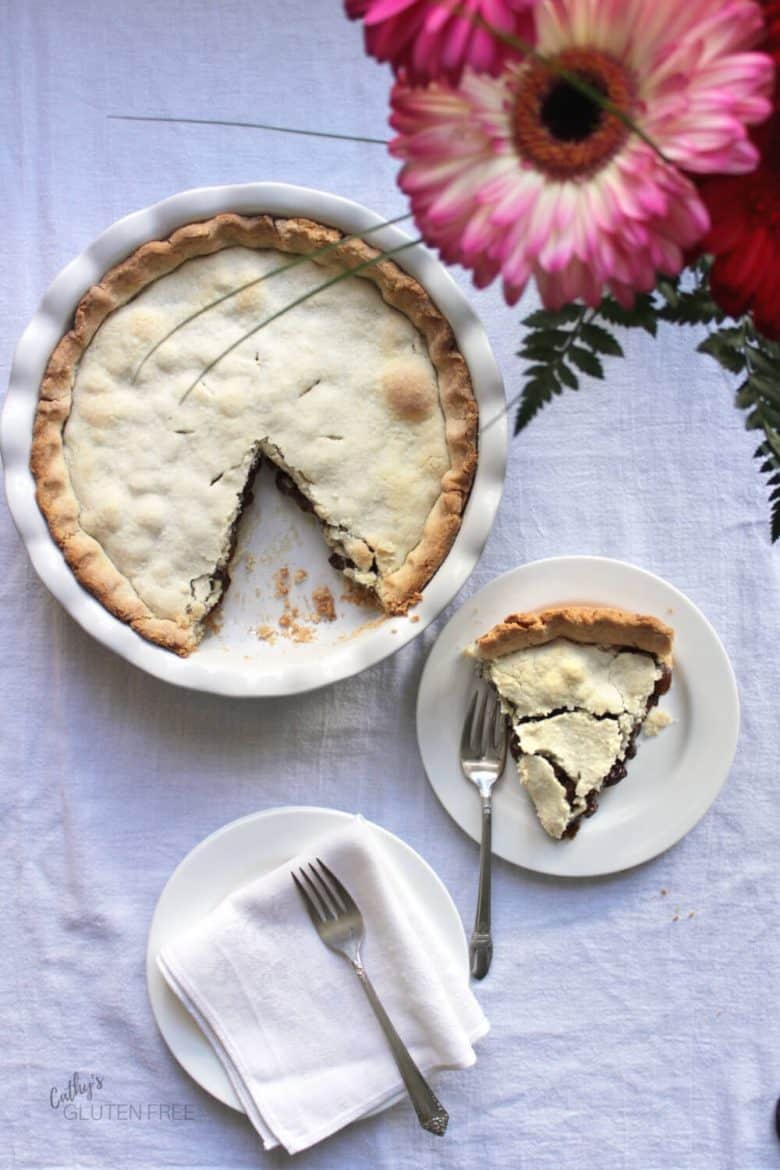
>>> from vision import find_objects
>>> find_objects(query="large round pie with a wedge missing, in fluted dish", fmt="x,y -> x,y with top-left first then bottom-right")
32,214 -> 477,654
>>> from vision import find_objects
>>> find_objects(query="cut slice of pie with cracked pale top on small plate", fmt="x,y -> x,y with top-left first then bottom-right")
472,605 -> 674,839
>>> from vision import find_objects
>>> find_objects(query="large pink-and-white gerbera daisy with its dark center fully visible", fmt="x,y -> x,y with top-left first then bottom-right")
391,0 -> 773,308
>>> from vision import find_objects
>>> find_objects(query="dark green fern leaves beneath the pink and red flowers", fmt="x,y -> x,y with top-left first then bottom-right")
515,259 -> 780,541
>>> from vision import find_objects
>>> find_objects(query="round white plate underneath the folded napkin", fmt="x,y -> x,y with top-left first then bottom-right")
146,806 -> 469,1112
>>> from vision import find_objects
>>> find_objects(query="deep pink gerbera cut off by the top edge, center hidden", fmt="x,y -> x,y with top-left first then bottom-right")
345,0 -> 536,83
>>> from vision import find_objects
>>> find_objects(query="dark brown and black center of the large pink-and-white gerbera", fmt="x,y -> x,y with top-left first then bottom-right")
512,49 -> 636,180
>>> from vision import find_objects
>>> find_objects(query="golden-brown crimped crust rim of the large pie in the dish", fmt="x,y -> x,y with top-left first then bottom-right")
30,213 -> 477,655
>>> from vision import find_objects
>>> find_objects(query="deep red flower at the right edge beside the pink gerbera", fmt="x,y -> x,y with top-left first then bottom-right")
699,0 -> 780,340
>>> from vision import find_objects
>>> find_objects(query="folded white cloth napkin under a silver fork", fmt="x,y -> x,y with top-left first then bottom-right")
158,817 -> 489,1154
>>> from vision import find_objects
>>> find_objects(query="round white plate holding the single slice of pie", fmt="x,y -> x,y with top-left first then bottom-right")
417,557 -> 739,878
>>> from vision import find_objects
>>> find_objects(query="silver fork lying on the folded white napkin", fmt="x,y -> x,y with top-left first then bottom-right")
291,858 -> 449,1136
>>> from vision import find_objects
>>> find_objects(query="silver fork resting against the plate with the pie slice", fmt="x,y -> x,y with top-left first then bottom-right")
461,688 -> 509,979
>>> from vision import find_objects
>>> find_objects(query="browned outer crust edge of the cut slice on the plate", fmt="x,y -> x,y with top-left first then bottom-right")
474,605 -> 674,667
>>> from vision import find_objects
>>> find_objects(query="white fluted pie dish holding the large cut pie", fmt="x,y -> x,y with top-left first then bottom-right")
0,183 -> 506,696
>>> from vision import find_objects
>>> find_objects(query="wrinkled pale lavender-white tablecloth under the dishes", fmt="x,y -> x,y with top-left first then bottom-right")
0,0 -> 780,1170
